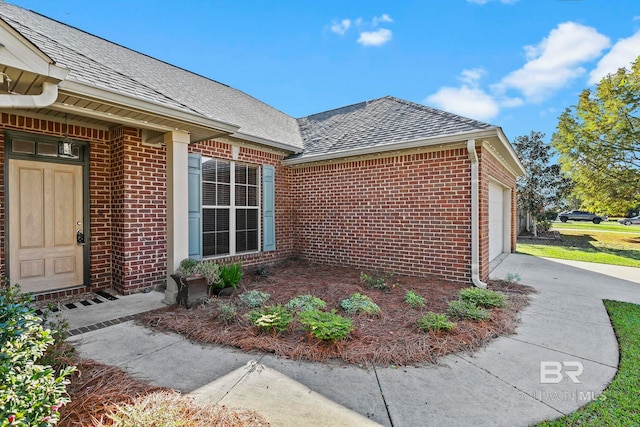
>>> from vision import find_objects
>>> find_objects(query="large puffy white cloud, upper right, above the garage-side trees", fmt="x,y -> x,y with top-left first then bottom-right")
492,22 -> 609,102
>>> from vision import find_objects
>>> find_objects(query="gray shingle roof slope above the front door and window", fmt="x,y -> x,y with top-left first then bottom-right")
0,2 -> 302,147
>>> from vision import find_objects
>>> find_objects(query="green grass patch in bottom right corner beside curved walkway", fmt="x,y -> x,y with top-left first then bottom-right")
538,301 -> 640,427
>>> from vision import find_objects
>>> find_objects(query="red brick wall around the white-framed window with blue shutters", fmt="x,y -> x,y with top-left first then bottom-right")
189,141 -> 293,266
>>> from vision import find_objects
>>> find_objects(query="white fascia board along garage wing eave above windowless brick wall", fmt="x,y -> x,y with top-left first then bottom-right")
282,128 -> 497,166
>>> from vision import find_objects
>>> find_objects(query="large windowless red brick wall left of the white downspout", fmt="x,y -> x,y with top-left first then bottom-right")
293,148 -> 471,281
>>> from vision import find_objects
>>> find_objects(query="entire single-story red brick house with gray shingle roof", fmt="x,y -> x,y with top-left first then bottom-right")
0,3 -> 523,302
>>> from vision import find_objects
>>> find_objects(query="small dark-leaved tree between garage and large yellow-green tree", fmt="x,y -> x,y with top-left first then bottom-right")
513,131 -> 571,234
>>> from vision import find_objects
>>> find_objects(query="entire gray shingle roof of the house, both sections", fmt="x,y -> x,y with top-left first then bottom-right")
0,0 -> 496,158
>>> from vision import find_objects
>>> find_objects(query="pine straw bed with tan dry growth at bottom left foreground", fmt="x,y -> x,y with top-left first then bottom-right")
57,360 -> 269,427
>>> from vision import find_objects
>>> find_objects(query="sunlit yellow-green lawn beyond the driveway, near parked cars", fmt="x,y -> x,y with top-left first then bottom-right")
517,222 -> 640,267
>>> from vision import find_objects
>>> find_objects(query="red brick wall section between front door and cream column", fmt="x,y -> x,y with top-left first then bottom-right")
110,127 -> 167,294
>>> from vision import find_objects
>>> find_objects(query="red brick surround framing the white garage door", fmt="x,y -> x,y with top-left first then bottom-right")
476,148 -> 517,280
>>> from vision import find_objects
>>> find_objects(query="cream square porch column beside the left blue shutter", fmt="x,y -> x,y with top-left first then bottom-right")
163,132 -> 189,304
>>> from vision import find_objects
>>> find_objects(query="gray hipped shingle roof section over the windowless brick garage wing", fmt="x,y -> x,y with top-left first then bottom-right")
291,96 -> 496,158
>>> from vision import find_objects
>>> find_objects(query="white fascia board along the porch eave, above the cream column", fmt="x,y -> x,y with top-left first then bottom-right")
60,80 -> 240,133
